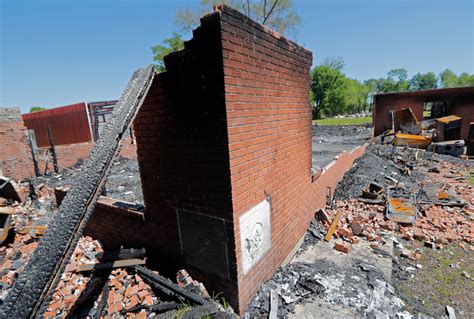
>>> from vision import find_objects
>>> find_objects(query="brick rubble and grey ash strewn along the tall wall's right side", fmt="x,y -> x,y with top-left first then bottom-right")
245,144 -> 474,318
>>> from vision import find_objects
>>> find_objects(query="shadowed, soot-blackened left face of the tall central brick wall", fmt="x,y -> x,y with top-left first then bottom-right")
135,10 -> 237,300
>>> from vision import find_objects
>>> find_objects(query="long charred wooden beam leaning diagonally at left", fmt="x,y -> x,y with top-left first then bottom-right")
0,65 -> 154,318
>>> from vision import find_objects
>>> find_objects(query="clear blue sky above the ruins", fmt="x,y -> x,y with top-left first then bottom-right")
0,0 -> 474,112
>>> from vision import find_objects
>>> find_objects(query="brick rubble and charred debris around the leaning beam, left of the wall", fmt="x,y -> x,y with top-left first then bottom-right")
0,174 -> 230,318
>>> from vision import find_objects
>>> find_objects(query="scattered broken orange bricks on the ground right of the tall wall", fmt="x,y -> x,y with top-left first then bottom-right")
320,149 -> 474,257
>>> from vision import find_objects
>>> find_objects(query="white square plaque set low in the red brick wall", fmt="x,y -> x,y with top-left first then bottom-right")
239,199 -> 272,274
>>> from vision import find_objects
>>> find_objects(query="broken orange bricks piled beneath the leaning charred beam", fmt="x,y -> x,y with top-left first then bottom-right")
0,234 -> 209,319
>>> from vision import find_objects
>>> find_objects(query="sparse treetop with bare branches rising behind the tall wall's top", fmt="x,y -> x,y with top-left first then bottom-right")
151,0 -> 300,71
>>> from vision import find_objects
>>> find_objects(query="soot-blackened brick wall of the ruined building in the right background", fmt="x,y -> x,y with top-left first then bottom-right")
374,86 -> 474,140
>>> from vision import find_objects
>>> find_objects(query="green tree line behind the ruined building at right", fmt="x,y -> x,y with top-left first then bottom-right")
310,58 -> 474,119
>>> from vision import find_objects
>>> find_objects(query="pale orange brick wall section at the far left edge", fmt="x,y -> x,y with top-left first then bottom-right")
0,108 -> 35,180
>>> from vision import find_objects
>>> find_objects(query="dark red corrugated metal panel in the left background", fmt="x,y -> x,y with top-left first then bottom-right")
22,102 -> 91,147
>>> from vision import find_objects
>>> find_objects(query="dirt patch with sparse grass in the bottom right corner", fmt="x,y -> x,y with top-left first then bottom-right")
393,243 -> 474,318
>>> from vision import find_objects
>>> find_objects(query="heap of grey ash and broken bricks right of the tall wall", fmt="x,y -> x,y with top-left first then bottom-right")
328,145 -> 474,252
